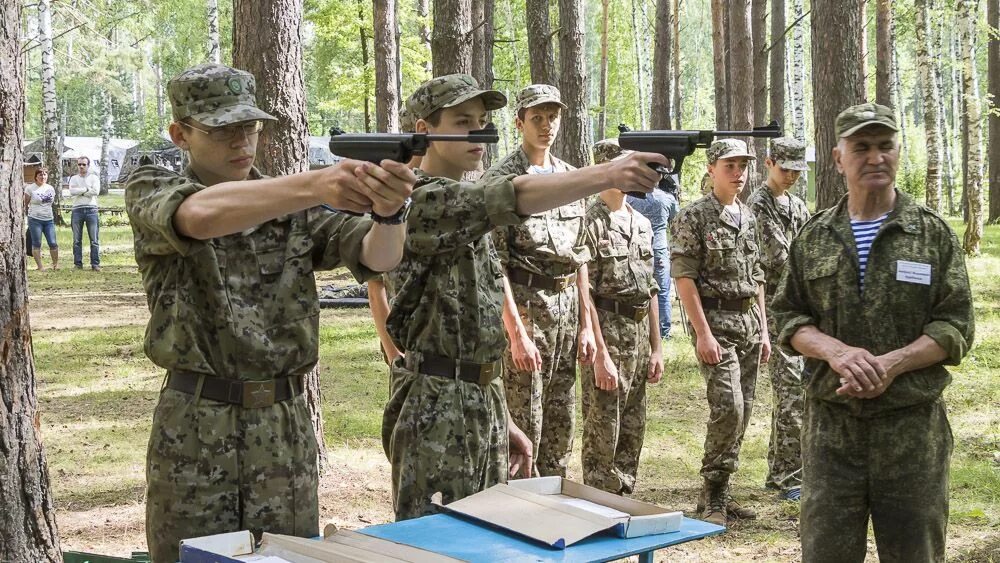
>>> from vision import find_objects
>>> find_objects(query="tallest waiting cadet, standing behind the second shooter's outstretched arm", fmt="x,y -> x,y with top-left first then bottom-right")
483,84 -> 594,477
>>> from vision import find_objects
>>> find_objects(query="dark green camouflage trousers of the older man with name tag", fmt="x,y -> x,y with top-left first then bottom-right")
799,399 -> 952,563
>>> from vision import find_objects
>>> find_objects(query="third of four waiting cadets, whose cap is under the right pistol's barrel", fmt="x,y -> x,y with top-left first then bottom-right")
670,139 -> 771,525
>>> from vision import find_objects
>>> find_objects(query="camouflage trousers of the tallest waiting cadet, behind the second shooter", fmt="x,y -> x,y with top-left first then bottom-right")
504,283 -> 579,477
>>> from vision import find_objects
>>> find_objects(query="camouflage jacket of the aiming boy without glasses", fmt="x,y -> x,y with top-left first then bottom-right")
386,170 -> 521,363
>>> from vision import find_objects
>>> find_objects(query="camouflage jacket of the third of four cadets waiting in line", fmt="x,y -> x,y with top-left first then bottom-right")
670,192 -> 764,299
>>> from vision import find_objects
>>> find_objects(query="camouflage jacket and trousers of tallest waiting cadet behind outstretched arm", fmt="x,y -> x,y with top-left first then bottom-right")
483,148 -> 590,476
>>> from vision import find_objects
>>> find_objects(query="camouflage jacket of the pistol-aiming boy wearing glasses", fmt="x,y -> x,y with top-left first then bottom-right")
125,166 -> 375,380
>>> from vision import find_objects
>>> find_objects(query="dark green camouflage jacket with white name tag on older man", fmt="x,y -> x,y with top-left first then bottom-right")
772,191 -> 975,416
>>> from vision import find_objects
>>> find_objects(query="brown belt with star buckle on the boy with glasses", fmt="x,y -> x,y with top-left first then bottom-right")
167,370 -> 303,409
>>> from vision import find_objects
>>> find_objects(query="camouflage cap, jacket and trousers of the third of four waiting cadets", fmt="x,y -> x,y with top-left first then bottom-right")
670,139 -> 764,490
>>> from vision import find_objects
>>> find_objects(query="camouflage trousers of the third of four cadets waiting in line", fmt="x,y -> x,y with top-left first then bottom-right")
695,307 -> 761,483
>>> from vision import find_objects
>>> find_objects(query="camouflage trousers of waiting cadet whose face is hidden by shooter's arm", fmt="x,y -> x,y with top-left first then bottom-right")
580,310 -> 650,494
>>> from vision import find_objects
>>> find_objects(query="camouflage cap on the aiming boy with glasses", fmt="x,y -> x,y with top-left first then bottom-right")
167,64 -> 278,127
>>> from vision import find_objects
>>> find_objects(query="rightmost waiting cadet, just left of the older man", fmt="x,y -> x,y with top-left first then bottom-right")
747,137 -> 809,500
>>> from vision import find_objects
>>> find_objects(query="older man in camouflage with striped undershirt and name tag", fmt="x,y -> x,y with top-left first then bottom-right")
772,104 -> 975,563
